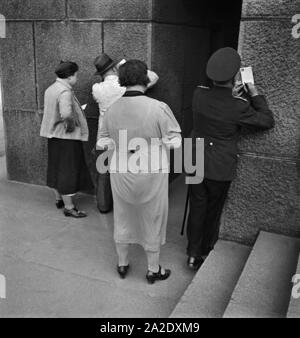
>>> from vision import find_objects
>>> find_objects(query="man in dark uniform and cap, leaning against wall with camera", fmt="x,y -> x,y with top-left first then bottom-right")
187,47 -> 274,270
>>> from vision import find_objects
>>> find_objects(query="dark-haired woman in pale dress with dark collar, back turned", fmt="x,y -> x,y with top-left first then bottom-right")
97,60 -> 181,283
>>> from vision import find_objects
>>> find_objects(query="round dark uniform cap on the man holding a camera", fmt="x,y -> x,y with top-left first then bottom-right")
206,47 -> 241,82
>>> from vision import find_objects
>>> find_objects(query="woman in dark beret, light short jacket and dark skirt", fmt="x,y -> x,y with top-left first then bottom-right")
40,61 -> 89,218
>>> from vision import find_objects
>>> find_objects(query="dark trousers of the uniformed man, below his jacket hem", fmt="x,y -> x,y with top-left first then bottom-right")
187,178 -> 231,259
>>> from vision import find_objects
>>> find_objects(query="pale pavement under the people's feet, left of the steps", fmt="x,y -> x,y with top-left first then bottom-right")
0,156 -> 194,318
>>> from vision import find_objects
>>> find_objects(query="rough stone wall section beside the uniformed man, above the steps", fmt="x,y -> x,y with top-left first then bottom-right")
221,0 -> 300,243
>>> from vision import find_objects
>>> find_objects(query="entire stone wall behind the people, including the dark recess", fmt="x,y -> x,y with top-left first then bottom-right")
0,0 -> 300,244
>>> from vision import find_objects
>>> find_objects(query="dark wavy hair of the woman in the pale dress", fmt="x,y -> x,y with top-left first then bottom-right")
119,60 -> 150,87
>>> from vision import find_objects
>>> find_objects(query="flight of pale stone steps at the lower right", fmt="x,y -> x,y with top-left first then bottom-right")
170,231 -> 300,318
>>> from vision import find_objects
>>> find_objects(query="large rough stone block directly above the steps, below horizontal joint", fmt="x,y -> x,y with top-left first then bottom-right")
221,156 -> 300,244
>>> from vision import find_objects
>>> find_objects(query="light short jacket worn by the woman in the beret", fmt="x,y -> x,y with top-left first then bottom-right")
40,78 -> 89,141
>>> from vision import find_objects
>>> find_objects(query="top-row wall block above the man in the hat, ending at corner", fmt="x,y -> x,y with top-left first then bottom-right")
68,0 -> 152,20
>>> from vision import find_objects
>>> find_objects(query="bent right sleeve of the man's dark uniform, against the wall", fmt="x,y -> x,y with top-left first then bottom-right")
239,95 -> 275,129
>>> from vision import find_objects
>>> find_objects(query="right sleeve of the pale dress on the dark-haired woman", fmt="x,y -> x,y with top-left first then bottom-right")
159,104 -> 181,148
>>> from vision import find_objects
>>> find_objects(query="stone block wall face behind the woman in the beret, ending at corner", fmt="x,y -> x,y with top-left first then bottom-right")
0,0 -> 152,184
